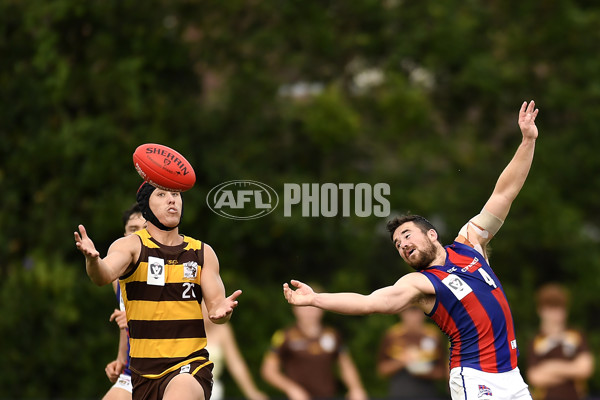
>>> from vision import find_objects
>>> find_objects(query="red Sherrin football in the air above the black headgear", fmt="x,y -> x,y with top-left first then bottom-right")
133,143 -> 196,192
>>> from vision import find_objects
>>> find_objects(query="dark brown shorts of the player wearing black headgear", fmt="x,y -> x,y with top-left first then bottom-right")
131,360 -> 214,400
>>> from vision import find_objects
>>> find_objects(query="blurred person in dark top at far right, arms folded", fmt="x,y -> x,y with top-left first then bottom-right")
527,283 -> 594,400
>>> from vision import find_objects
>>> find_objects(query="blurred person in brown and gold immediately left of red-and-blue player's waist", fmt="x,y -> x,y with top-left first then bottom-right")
377,307 -> 448,399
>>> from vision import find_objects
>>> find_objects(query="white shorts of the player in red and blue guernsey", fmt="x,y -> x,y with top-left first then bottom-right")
450,367 -> 531,400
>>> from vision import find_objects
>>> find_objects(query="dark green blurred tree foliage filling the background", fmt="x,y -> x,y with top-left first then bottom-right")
0,0 -> 600,398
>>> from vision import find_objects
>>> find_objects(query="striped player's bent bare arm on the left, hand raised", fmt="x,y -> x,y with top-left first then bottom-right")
74,225 -> 141,286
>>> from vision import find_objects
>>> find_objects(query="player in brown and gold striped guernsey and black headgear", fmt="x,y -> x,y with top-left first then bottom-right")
74,182 -> 242,400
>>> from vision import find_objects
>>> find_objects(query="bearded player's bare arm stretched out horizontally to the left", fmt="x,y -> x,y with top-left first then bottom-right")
283,273 -> 435,315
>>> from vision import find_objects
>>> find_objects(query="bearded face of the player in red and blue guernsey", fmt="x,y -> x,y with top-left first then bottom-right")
393,221 -> 437,271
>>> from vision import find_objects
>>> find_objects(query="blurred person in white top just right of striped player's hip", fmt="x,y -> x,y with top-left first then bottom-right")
202,302 -> 268,400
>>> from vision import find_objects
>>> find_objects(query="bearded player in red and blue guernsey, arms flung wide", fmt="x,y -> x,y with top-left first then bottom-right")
283,101 -> 538,400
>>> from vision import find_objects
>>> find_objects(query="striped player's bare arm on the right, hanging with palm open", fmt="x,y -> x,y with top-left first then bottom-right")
201,243 -> 242,324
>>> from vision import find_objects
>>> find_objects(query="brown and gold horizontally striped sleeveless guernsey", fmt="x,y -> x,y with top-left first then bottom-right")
119,229 -> 211,379
